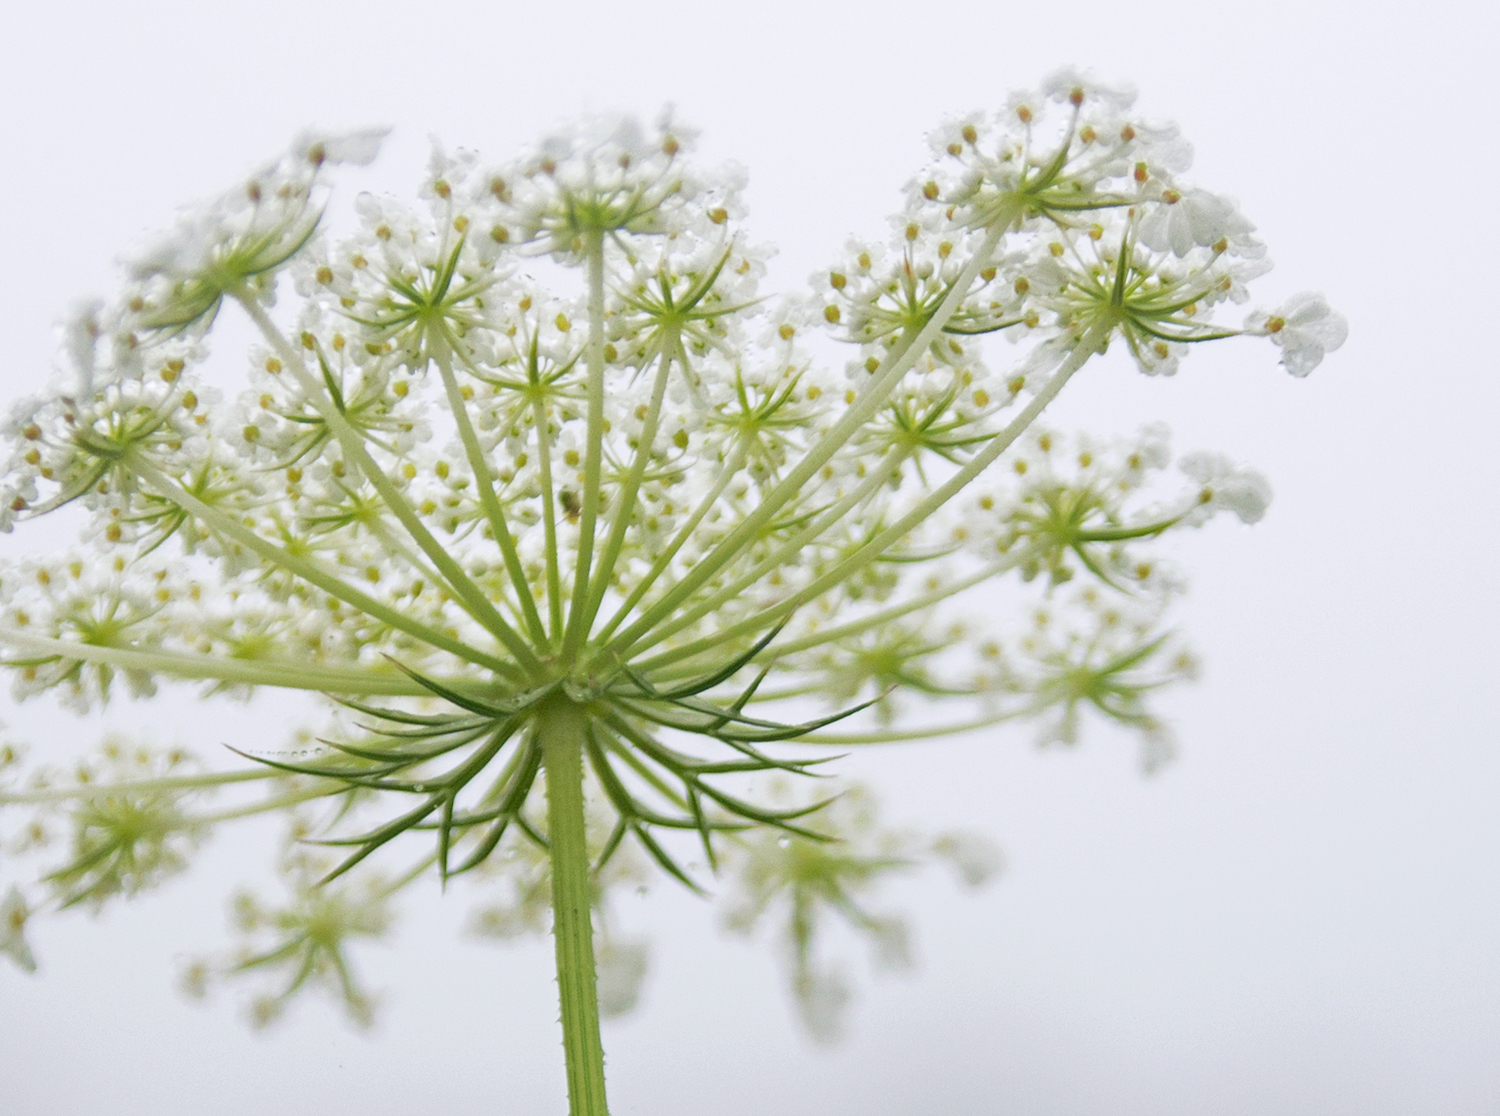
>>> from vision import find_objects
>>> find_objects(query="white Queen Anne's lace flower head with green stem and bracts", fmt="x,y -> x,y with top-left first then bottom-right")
0,78 -> 1346,1113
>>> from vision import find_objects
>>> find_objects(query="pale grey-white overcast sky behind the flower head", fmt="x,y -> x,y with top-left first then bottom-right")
0,0 -> 1500,1116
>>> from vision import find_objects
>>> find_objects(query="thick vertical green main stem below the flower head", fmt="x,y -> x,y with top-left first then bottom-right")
537,698 -> 609,1116
